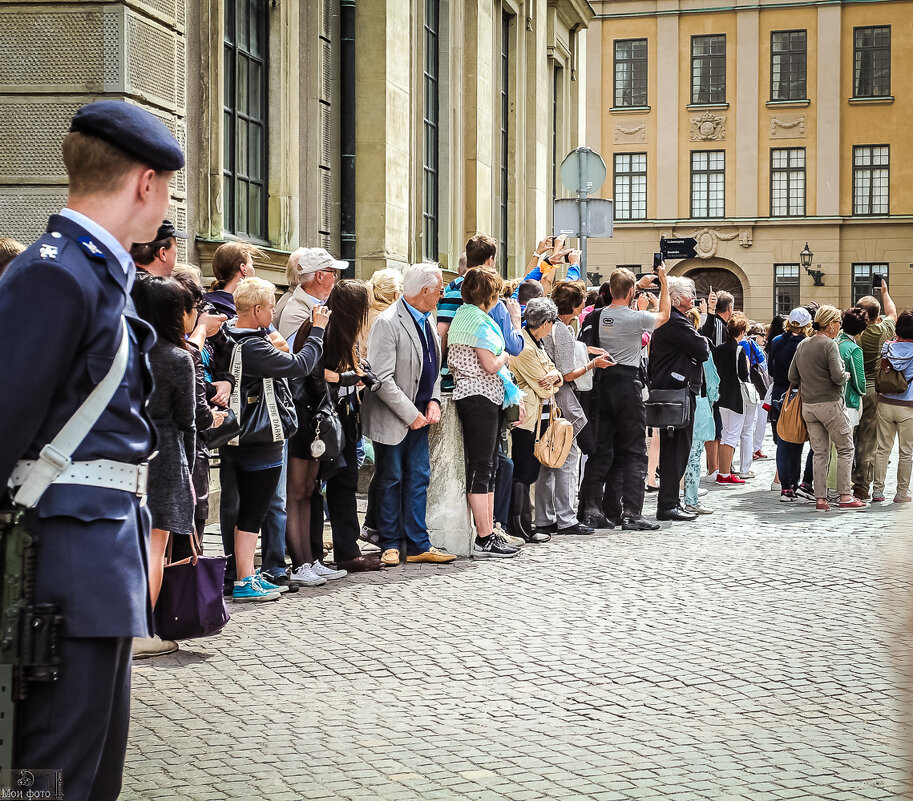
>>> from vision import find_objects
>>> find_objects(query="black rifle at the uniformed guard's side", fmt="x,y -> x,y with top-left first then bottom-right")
0,504 -> 63,771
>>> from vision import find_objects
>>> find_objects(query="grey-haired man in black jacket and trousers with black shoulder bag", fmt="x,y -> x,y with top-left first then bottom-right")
649,277 -> 710,521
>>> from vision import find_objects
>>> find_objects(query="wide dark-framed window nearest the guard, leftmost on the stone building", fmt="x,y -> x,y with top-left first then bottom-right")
222,0 -> 269,242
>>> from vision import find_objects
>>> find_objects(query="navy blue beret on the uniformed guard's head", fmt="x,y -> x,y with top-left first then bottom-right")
70,100 -> 184,171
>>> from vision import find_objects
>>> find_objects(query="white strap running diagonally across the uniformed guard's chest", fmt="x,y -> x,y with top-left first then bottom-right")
13,317 -> 130,509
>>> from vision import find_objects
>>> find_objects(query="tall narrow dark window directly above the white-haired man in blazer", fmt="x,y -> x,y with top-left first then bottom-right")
422,0 -> 441,261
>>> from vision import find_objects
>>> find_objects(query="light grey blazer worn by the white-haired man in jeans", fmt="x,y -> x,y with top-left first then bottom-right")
361,298 -> 441,445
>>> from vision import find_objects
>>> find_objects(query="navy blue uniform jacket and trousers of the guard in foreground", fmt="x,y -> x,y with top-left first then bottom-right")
0,216 -> 155,801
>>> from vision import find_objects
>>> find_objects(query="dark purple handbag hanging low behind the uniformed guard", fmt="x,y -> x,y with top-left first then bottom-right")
152,534 -> 230,640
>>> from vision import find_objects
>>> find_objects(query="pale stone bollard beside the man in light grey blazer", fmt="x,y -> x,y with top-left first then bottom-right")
426,395 -> 475,556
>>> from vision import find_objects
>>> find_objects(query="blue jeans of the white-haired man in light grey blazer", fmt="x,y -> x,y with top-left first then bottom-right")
374,427 -> 431,556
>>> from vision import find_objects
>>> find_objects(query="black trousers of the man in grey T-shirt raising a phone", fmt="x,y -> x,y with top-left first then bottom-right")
580,365 -> 647,518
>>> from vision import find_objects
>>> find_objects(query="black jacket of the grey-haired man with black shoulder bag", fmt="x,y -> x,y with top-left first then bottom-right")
648,308 -> 710,395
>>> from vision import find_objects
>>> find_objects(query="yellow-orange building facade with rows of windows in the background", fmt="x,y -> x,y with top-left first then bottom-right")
587,0 -> 913,321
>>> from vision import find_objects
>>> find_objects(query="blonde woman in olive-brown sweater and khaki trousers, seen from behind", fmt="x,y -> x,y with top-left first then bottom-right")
789,306 -> 868,512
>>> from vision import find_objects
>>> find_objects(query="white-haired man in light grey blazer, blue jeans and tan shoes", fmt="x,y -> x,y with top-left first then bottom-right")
361,264 -> 456,567
